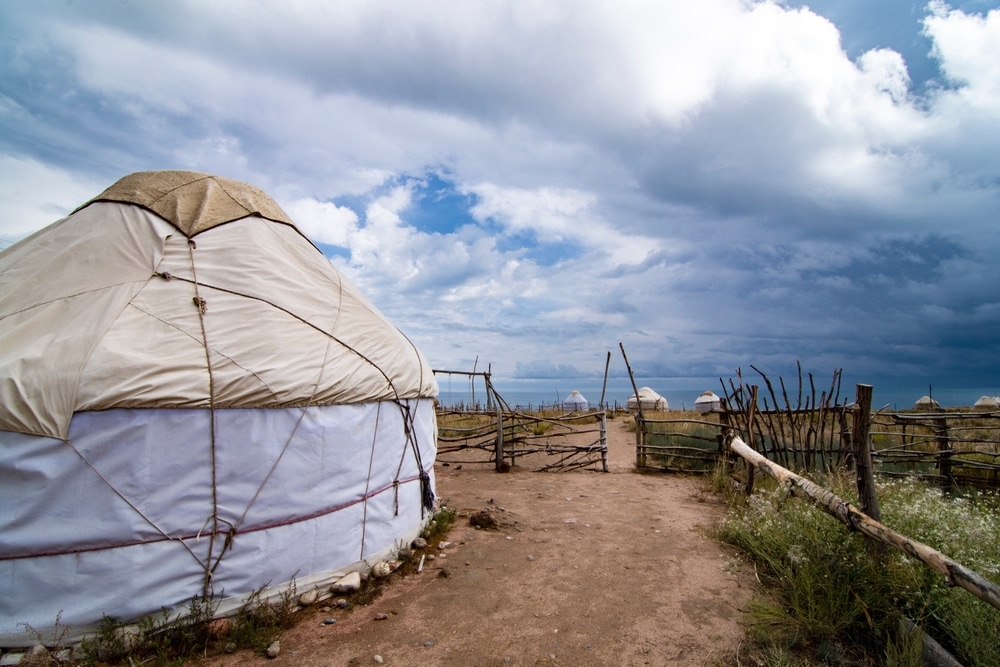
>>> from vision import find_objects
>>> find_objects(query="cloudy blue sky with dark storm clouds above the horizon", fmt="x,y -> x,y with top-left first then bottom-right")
0,0 -> 1000,389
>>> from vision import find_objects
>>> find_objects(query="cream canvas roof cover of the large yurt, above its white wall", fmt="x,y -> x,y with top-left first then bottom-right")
0,172 -> 437,438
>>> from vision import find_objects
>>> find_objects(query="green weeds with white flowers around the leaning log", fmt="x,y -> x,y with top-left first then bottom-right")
716,476 -> 1000,667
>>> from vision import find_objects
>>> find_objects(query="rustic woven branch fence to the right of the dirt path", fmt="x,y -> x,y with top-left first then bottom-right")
633,388 -> 1000,491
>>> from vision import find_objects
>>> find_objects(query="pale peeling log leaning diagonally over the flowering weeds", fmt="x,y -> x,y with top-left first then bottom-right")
727,434 -> 1000,609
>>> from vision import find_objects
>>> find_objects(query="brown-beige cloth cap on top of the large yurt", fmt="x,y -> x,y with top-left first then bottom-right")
84,171 -> 293,237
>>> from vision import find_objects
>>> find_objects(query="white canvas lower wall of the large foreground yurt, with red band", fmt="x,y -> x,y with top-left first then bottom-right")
0,399 -> 436,646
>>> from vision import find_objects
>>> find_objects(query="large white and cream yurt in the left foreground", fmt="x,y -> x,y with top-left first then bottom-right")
0,171 -> 437,646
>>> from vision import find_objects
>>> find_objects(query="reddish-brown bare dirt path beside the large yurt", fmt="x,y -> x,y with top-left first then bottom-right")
198,419 -> 753,667
